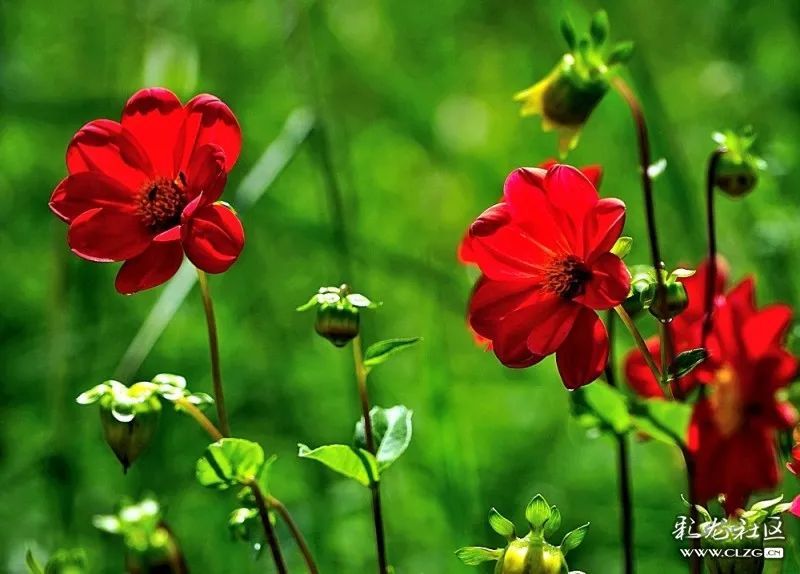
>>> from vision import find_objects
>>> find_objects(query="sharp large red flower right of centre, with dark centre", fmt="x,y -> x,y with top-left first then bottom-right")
469,165 -> 630,389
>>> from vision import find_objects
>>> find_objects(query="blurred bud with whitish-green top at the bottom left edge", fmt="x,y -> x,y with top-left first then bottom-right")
93,497 -> 189,574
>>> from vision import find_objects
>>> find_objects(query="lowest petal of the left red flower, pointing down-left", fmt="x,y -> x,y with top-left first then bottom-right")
115,241 -> 183,295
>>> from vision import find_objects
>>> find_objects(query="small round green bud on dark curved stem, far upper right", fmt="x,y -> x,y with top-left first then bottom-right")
713,128 -> 766,197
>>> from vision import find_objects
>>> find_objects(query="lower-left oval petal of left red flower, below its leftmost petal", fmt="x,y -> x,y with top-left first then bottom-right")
68,208 -> 151,261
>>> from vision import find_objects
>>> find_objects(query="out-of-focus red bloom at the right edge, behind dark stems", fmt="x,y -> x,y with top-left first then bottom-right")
626,258 -> 798,513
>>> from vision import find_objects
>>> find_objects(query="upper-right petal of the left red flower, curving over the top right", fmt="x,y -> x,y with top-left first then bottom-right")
175,94 -> 242,171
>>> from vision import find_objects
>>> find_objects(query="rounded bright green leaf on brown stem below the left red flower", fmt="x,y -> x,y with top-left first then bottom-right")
196,438 -> 264,490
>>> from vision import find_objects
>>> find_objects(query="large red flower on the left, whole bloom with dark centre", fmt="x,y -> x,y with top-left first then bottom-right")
50,88 -> 244,294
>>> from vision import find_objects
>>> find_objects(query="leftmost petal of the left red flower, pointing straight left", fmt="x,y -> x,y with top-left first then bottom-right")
50,171 -> 138,223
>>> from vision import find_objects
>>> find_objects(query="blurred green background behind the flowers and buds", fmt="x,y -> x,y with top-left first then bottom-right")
0,0 -> 800,574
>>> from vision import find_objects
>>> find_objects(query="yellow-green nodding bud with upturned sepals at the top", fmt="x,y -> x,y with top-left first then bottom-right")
514,11 -> 633,156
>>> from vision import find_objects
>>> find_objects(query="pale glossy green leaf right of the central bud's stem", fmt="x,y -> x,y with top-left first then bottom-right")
355,405 -> 414,472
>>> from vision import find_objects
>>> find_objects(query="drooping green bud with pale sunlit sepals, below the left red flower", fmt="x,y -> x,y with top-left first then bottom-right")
77,381 -> 161,472
